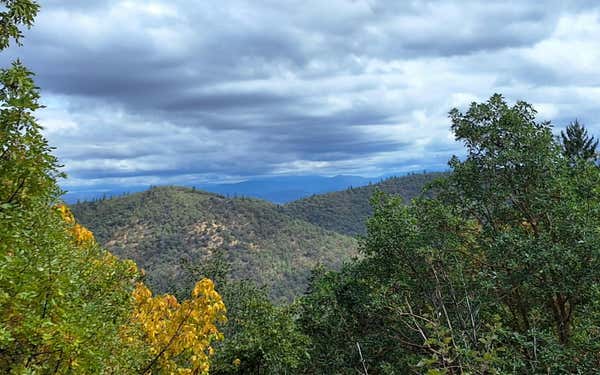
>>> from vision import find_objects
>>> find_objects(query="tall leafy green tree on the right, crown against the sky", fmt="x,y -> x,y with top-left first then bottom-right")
448,95 -> 600,352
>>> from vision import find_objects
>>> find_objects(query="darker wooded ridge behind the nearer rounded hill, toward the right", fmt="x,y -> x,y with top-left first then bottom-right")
283,172 -> 444,236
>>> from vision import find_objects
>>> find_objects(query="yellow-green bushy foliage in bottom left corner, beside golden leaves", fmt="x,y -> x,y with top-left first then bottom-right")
0,201 -> 137,373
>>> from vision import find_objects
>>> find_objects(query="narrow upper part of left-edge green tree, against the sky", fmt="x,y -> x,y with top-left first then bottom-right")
0,0 -> 60,210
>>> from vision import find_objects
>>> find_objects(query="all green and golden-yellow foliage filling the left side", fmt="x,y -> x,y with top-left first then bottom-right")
0,0 -> 224,374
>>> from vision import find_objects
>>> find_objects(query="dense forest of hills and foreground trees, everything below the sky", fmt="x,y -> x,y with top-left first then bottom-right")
0,0 -> 600,375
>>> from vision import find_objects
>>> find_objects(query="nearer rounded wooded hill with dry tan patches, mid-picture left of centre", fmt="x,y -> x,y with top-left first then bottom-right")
72,187 -> 356,299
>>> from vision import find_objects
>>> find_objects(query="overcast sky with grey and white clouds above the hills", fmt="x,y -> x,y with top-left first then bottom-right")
3,0 -> 600,194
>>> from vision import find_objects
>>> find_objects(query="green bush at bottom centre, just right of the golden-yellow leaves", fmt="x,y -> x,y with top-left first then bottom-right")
183,249 -> 308,374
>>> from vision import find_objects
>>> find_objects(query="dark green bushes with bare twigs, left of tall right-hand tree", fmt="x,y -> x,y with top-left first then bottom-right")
303,198 -> 506,374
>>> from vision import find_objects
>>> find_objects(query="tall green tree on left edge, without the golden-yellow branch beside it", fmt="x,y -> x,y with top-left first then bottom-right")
0,0 -> 137,373
